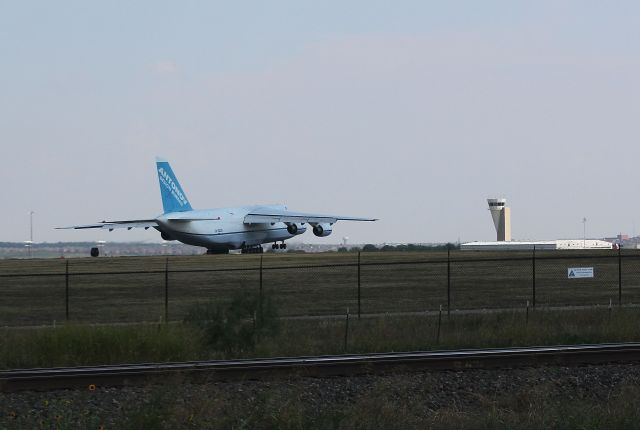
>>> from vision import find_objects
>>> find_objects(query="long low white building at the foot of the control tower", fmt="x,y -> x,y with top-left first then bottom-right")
460,239 -> 613,251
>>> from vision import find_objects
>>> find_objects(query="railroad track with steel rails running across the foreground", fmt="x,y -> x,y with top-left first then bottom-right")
0,343 -> 640,391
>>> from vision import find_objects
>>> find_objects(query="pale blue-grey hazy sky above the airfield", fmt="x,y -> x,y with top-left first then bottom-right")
0,0 -> 640,243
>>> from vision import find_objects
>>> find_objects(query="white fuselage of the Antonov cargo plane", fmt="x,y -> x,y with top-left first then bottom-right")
156,205 -> 306,250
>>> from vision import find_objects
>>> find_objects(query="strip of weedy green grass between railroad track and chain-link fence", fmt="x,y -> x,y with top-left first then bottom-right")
0,308 -> 640,369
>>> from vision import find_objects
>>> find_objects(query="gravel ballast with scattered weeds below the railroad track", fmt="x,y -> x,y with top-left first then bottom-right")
0,364 -> 640,429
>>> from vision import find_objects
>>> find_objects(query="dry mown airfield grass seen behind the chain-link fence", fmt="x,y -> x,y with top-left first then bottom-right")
0,250 -> 640,326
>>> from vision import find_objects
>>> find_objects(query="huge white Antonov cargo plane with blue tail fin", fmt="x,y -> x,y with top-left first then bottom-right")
57,157 -> 377,254
